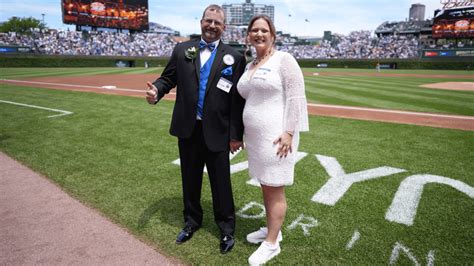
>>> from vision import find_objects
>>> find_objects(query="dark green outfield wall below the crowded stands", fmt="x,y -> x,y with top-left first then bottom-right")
0,54 -> 474,70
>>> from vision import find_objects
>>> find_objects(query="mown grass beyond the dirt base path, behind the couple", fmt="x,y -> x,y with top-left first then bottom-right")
0,68 -> 474,115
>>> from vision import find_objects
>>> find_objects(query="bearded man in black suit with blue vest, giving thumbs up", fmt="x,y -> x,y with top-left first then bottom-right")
146,5 -> 246,254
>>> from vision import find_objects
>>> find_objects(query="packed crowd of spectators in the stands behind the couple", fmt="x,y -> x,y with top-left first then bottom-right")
0,27 -> 419,59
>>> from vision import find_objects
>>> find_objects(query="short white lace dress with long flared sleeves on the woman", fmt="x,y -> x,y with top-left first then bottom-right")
237,51 -> 309,187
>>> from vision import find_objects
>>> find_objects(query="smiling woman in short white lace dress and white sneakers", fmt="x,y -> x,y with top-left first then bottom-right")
237,15 -> 309,264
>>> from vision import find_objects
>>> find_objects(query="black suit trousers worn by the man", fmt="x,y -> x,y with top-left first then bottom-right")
178,120 -> 235,235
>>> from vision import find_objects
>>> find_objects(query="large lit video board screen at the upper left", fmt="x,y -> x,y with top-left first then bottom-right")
62,0 -> 148,31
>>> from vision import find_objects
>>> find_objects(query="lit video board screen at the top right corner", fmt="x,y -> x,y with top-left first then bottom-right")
432,8 -> 474,38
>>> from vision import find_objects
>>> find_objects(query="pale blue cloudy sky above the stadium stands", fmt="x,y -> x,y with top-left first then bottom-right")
0,0 -> 441,36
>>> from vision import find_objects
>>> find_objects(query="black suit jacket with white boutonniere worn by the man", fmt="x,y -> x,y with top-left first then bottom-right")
153,39 -> 246,152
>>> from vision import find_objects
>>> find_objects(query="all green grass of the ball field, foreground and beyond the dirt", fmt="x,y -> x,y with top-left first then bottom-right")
0,68 -> 474,265
